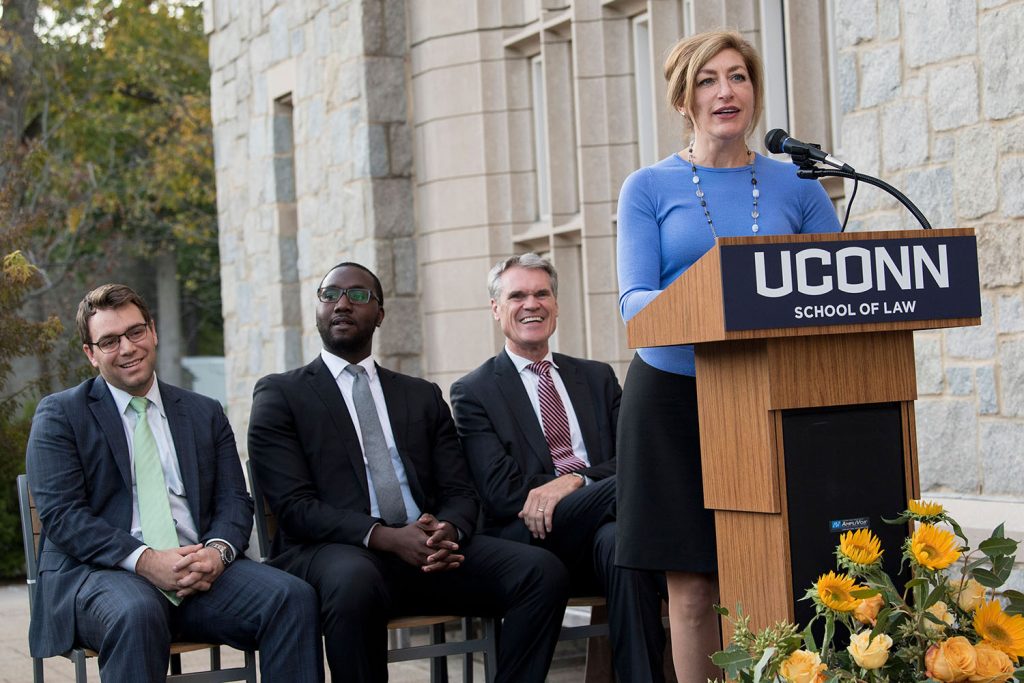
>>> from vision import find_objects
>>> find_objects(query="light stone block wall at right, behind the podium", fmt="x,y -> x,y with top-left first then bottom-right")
836,0 -> 1024,509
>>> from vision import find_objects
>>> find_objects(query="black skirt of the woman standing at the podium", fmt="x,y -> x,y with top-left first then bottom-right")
615,355 -> 718,573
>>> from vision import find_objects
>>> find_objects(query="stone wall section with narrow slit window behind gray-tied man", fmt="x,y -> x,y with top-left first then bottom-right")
205,0 -> 422,444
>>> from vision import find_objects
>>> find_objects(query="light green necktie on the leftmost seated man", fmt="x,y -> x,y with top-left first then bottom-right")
128,396 -> 181,605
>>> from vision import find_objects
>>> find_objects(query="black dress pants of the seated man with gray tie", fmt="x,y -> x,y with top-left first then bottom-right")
303,536 -> 568,683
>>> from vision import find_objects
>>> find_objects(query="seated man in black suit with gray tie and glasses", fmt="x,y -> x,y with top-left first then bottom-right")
249,263 -> 568,683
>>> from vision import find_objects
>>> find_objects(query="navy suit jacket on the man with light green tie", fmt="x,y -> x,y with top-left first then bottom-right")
26,377 -> 253,657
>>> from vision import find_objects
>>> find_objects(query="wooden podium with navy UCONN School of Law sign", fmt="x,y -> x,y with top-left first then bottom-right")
628,229 -> 981,634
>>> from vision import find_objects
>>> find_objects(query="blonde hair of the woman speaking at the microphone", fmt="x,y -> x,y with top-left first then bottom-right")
665,31 -> 765,134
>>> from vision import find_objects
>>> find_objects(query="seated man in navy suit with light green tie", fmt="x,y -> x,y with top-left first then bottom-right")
27,285 -> 324,683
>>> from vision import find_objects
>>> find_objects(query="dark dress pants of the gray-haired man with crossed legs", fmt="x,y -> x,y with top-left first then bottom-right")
531,477 -> 667,683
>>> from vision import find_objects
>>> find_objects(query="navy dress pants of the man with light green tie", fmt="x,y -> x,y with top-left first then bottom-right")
75,557 -> 324,683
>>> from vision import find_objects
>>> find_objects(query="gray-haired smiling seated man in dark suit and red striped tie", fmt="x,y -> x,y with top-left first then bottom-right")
452,254 -> 665,683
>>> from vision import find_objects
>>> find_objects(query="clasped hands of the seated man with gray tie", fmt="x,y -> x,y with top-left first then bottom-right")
369,513 -> 466,571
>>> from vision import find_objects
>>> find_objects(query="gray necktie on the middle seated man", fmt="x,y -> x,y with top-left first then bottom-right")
345,365 -> 409,524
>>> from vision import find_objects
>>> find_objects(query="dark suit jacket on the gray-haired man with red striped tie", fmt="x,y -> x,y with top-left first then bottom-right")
452,350 -> 622,541
